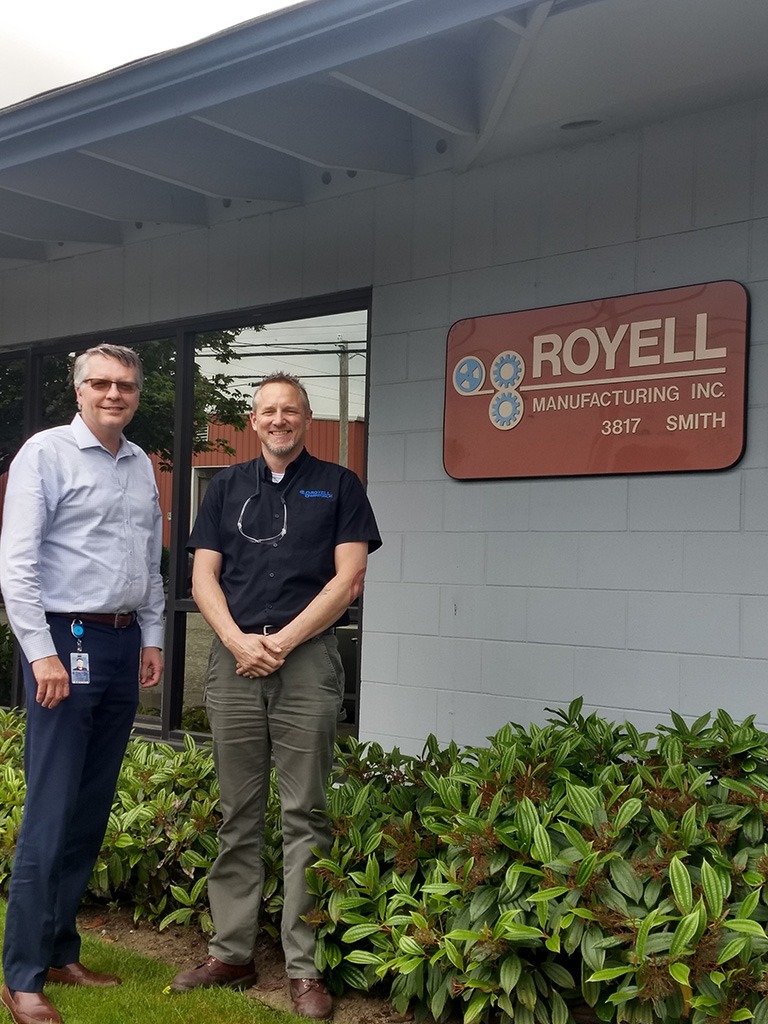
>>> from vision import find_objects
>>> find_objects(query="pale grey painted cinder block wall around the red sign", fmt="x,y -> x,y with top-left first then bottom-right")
0,98 -> 768,752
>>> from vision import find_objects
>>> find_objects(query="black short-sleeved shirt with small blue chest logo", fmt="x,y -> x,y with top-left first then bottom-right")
187,450 -> 381,633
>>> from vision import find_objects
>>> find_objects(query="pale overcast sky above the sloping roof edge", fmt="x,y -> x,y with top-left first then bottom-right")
0,0 -> 307,109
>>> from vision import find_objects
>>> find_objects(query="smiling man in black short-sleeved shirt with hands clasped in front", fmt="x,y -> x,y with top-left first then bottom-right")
171,374 -> 381,1019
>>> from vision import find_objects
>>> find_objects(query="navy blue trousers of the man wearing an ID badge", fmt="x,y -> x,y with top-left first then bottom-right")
3,615 -> 141,992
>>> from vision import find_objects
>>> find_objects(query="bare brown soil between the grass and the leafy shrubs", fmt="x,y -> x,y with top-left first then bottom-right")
78,906 -> 403,1024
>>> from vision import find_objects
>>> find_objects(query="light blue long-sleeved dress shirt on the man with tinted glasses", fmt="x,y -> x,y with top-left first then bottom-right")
0,415 -> 165,662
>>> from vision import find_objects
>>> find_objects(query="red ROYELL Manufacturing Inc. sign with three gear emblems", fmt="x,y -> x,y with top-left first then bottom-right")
443,281 -> 748,480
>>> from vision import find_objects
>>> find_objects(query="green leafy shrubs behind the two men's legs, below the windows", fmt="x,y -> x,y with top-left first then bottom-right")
0,711 -> 282,936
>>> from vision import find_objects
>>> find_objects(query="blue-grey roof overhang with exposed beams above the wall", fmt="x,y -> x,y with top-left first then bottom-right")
0,0 -> 768,269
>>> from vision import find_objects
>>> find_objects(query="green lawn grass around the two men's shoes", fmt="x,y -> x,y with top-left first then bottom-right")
0,901 -> 297,1024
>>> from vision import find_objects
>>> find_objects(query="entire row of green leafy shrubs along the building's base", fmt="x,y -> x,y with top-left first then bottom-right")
0,700 -> 768,1024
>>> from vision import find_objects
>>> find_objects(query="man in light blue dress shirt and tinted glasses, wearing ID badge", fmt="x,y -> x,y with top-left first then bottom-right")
0,344 -> 165,1024
